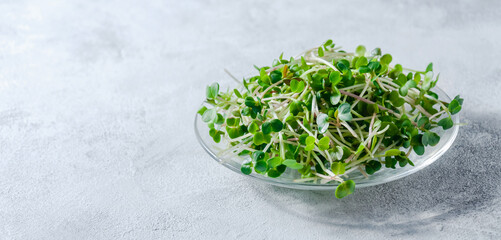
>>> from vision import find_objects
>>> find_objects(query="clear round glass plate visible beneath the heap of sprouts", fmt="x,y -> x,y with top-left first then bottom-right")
195,87 -> 459,190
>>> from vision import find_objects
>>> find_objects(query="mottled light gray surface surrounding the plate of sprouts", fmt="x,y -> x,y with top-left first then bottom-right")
0,0 -> 501,239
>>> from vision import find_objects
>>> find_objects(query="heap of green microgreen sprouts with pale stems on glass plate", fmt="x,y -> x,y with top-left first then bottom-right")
198,40 -> 463,198
